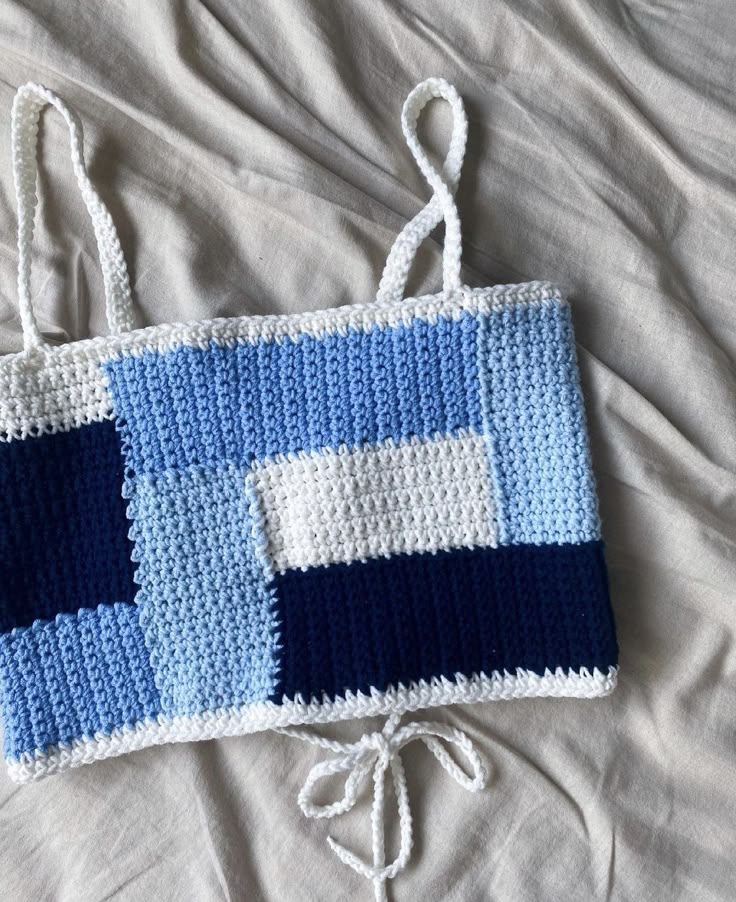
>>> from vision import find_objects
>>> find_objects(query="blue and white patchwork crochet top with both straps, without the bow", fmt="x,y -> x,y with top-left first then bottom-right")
0,80 -> 617,781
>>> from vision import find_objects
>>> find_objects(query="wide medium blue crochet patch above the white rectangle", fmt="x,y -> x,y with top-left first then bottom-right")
105,313 -> 481,474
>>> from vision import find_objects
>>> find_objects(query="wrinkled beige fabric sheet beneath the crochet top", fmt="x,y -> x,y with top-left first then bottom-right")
0,0 -> 736,902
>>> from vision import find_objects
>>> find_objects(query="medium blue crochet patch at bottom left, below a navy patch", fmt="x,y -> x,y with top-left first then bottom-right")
0,604 -> 161,758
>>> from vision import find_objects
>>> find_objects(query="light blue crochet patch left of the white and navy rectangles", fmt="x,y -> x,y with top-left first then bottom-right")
127,464 -> 278,715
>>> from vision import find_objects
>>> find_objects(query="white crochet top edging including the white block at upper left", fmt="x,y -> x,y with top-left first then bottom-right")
0,282 -> 563,441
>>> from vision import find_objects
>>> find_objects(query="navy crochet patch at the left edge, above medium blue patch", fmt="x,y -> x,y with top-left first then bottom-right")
0,421 -> 136,632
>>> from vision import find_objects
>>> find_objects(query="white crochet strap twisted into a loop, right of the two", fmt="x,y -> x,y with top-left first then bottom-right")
376,78 -> 468,303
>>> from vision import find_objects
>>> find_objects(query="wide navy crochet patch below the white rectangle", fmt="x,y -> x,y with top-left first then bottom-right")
274,542 -> 618,701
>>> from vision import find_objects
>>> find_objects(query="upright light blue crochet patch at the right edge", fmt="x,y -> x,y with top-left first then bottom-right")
478,300 -> 600,545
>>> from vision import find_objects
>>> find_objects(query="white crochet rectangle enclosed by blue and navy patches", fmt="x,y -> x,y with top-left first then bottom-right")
248,431 -> 497,572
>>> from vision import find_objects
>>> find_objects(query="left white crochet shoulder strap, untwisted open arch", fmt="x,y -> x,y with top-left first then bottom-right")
11,82 -> 133,351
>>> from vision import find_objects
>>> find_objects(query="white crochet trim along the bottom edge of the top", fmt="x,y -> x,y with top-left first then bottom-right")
6,667 -> 618,783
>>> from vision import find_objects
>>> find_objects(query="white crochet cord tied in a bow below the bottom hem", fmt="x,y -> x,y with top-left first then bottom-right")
277,714 -> 488,902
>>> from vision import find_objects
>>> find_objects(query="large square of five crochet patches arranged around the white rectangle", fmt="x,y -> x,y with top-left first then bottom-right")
100,296 -> 615,714
